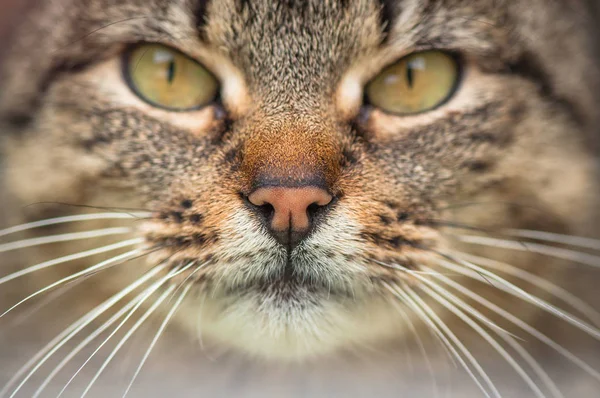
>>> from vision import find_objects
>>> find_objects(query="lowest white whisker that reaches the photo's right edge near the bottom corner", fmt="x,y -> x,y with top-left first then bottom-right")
436,262 -> 600,380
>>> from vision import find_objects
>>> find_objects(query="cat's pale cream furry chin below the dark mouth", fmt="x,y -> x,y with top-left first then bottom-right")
179,294 -> 407,362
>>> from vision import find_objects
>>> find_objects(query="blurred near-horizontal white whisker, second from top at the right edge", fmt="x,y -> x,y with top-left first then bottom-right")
457,235 -> 600,267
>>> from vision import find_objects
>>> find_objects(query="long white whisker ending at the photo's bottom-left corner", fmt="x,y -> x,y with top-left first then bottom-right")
0,264 -> 167,398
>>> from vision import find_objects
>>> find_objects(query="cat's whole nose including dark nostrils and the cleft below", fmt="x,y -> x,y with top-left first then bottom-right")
248,186 -> 333,249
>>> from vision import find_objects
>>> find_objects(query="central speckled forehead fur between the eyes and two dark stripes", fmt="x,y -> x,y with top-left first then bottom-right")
200,0 -> 384,107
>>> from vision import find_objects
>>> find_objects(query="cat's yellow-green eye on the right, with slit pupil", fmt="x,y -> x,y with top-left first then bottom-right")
366,51 -> 459,115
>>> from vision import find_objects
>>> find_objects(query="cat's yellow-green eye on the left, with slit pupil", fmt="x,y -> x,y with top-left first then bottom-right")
125,44 -> 219,111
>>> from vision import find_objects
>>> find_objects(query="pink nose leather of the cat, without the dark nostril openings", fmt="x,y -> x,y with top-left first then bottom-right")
248,187 -> 333,232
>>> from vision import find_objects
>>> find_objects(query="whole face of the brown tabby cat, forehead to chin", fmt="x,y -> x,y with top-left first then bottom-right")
0,0 -> 600,358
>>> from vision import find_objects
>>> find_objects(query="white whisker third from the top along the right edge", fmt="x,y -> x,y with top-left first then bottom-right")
451,251 -> 600,326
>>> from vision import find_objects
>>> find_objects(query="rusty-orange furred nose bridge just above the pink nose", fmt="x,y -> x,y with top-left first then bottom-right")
242,115 -> 340,190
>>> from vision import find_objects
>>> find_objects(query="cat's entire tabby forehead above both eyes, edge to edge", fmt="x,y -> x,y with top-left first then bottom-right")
0,0 -> 591,134
